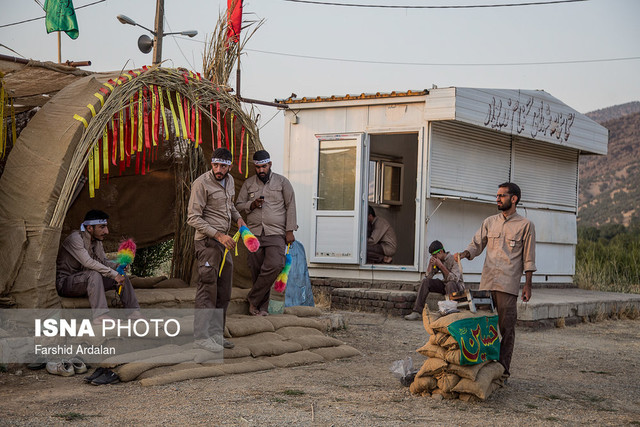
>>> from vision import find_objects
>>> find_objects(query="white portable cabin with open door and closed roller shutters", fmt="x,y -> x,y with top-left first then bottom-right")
278,87 -> 608,283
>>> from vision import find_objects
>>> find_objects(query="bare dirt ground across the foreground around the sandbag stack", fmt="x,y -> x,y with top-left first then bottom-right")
0,312 -> 640,426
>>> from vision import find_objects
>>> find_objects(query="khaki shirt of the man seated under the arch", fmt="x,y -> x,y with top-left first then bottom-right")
56,230 -> 118,282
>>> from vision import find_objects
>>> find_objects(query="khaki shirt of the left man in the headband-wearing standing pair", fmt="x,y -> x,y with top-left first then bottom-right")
187,171 -> 240,240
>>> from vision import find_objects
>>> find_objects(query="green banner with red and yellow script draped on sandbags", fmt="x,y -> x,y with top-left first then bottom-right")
447,316 -> 500,365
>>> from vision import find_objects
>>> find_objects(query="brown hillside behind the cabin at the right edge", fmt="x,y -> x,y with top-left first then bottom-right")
578,107 -> 640,226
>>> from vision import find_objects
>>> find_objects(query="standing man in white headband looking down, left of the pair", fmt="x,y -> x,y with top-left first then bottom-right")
187,148 -> 245,352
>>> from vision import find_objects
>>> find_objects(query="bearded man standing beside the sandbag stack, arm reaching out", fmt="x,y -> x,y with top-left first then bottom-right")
456,182 -> 536,375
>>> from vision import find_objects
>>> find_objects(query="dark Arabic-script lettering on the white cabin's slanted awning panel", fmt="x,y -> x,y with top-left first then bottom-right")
484,96 -> 575,142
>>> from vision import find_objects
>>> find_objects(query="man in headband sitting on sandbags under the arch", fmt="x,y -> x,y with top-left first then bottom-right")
56,209 -> 140,324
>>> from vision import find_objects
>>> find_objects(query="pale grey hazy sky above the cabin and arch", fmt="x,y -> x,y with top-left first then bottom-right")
0,0 -> 640,171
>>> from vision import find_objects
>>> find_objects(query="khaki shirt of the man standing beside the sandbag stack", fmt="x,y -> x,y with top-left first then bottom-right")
467,213 -> 536,295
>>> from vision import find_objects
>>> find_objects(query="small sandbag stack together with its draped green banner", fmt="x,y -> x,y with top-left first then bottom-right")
409,308 -> 504,401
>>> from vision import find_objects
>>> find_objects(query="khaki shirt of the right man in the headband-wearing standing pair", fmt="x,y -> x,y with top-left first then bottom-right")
236,172 -> 298,236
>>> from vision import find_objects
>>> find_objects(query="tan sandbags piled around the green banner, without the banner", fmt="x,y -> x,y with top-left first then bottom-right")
409,308 -> 504,402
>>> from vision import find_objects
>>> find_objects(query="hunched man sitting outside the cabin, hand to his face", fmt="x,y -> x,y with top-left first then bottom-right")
404,240 -> 464,320
